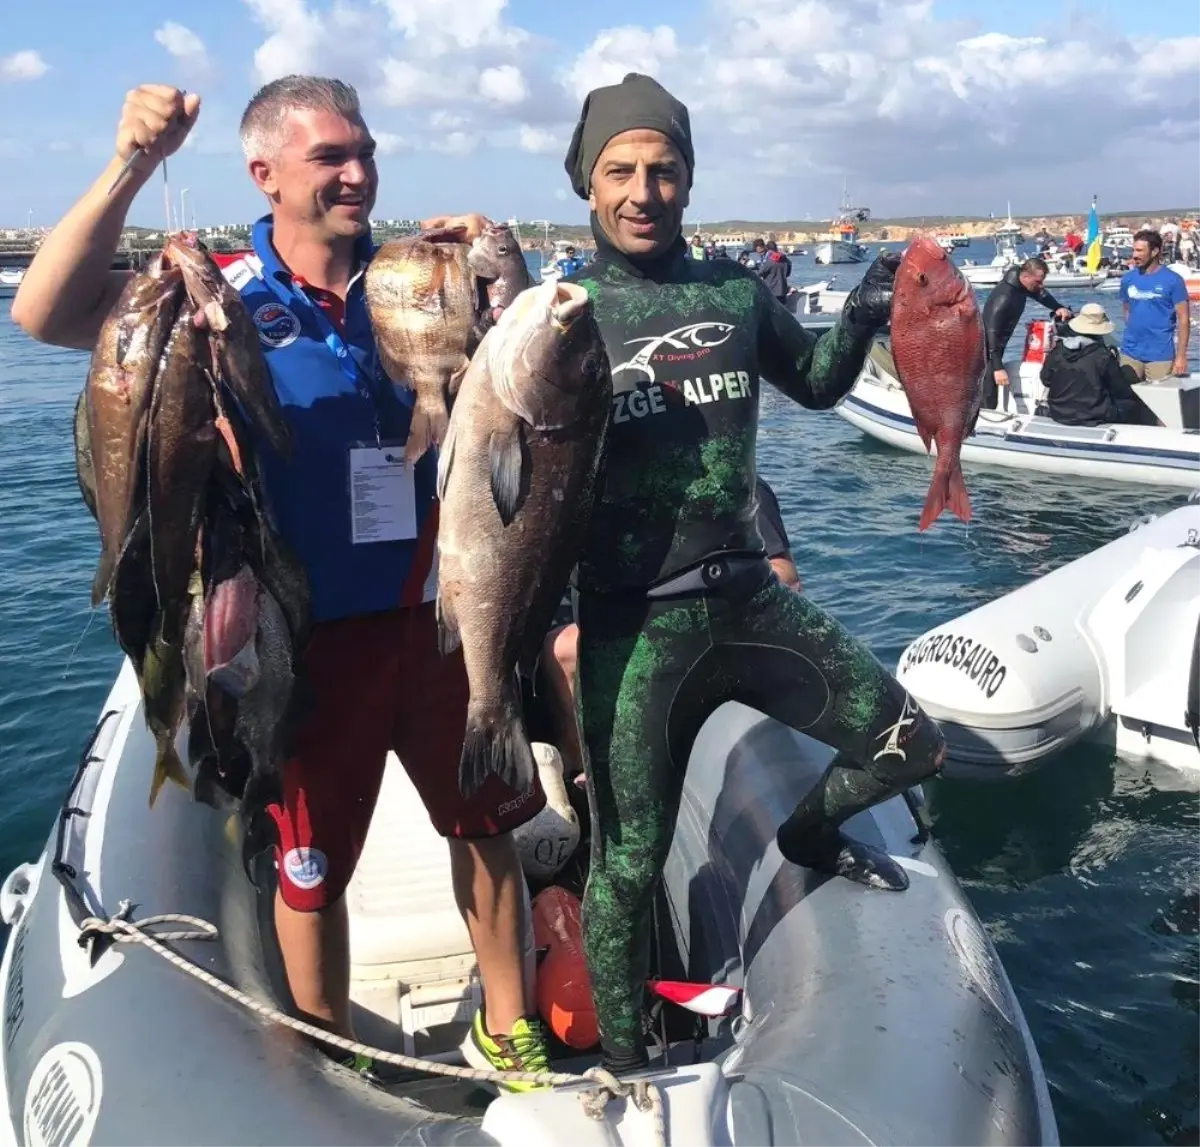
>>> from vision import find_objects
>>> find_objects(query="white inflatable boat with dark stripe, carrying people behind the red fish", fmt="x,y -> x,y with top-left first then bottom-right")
835,319 -> 1200,490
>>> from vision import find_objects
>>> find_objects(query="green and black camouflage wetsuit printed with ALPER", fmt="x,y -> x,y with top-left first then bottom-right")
570,235 -> 942,1070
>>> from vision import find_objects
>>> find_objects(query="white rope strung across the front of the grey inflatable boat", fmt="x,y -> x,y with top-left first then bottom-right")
79,900 -> 667,1147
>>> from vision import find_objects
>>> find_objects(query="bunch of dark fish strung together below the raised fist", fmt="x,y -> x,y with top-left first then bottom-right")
74,235 -> 310,817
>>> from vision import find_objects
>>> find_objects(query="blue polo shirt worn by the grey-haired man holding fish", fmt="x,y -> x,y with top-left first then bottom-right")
223,216 -> 438,621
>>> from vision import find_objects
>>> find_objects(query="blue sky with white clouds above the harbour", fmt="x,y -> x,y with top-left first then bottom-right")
0,0 -> 1200,226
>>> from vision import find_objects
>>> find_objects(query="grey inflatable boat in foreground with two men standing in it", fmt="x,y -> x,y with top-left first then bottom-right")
0,663 -> 1058,1147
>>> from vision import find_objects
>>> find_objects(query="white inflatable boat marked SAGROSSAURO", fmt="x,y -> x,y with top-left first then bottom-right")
896,502 -> 1200,774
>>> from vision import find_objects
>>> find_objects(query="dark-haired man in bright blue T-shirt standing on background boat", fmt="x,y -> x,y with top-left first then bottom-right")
1121,230 -> 1190,383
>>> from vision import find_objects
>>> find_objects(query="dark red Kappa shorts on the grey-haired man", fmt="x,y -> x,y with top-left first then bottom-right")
268,602 -> 546,912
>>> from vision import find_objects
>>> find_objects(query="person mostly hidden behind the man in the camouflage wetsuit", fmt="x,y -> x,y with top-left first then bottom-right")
522,478 -> 804,781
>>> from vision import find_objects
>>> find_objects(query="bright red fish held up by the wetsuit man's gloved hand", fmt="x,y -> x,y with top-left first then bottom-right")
892,235 -> 986,530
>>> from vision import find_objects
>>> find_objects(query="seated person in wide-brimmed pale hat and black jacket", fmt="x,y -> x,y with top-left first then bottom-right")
1042,302 -> 1163,426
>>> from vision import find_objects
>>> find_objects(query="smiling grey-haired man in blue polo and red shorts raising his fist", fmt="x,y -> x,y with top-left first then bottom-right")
12,76 -> 547,1089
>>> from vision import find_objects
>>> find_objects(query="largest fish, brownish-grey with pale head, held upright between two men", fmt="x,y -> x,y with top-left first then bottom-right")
438,283 -> 612,795
